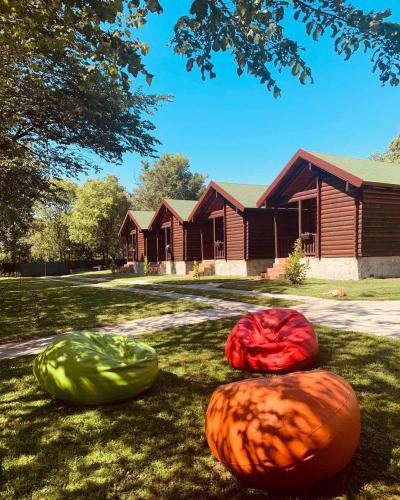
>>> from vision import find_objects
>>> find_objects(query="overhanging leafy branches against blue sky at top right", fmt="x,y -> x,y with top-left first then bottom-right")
172,0 -> 400,96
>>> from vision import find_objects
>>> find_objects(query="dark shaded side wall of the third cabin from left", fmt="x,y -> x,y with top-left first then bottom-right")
246,209 -> 275,259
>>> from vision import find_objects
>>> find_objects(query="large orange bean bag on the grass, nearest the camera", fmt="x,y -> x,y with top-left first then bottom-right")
206,370 -> 360,488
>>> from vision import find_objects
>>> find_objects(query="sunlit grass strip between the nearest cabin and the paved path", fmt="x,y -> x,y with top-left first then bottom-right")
222,278 -> 400,300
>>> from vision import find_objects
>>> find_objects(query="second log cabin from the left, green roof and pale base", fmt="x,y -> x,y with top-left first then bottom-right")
149,199 -> 201,274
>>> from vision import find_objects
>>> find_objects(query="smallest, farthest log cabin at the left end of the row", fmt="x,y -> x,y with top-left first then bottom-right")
118,210 -> 155,273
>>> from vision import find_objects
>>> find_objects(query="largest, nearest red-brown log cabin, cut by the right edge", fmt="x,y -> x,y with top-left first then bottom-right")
257,149 -> 400,279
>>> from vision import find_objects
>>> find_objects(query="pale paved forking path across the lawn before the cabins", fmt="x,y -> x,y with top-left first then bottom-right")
0,278 -> 400,359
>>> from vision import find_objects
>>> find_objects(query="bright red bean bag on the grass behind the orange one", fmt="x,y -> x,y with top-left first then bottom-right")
225,309 -> 318,373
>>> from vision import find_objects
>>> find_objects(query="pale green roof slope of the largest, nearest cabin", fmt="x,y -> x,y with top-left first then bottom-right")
308,151 -> 400,185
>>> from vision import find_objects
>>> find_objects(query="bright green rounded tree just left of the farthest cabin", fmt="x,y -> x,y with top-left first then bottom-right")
70,175 -> 129,260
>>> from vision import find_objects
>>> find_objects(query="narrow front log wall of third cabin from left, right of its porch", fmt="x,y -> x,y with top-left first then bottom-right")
224,202 -> 246,260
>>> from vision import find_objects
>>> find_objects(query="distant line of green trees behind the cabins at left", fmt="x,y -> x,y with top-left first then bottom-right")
0,153 -> 206,262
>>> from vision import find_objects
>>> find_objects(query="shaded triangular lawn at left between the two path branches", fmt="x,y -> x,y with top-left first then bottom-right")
0,278 -> 206,342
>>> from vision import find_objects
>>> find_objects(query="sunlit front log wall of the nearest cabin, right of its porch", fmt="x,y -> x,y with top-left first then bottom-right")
320,173 -> 358,257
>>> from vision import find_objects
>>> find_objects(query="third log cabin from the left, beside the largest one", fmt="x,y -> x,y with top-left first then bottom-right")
189,182 -> 275,276
